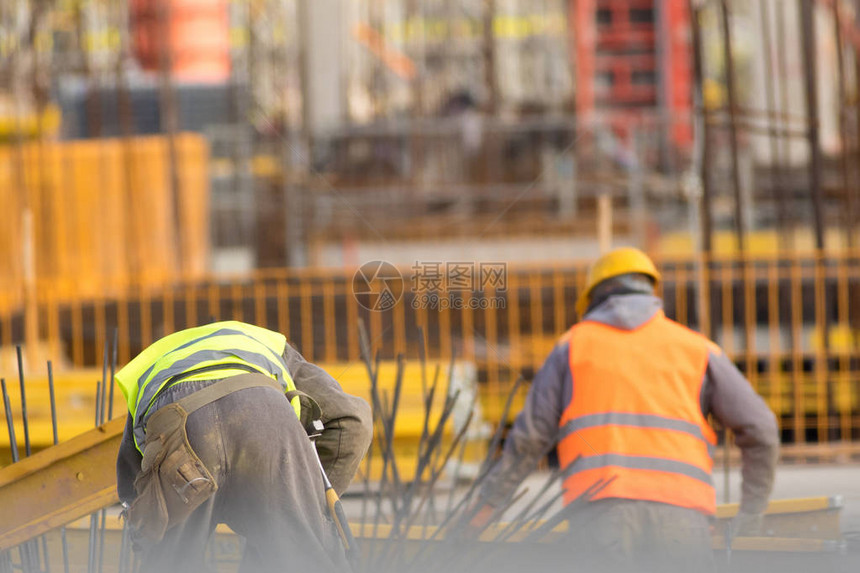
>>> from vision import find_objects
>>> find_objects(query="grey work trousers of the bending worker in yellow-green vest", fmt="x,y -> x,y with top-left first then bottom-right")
141,381 -> 348,573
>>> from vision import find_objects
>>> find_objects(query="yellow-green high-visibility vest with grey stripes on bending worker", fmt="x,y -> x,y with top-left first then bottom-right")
116,321 -> 301,452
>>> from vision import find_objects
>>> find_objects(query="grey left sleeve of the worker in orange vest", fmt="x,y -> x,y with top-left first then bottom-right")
479,343 -> 572,507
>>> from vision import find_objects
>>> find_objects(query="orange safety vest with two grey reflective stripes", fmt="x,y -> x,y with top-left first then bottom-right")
558,311 -> 719,515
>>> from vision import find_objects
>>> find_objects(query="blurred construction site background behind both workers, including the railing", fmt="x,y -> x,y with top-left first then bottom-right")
0,0 -> 860,457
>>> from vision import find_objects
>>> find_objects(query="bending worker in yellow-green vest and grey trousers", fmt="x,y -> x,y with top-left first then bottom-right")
116,322 -> 372,573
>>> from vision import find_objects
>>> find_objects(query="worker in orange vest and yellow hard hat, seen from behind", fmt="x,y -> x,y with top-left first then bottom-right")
470,248 -> 779,573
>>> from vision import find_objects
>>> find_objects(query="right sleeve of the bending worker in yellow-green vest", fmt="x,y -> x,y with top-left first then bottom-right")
284,344 -> 373,495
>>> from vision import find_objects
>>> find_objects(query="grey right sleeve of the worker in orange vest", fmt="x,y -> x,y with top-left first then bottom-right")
704,352 -> 779,513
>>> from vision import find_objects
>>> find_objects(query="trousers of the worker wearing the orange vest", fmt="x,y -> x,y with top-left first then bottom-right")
565,499 -> 715,573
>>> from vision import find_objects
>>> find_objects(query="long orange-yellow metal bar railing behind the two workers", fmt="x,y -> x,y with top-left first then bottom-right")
0,252 -> 860,444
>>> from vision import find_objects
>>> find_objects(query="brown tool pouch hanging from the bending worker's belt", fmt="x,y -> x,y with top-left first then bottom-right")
128,402 -> 218,550
